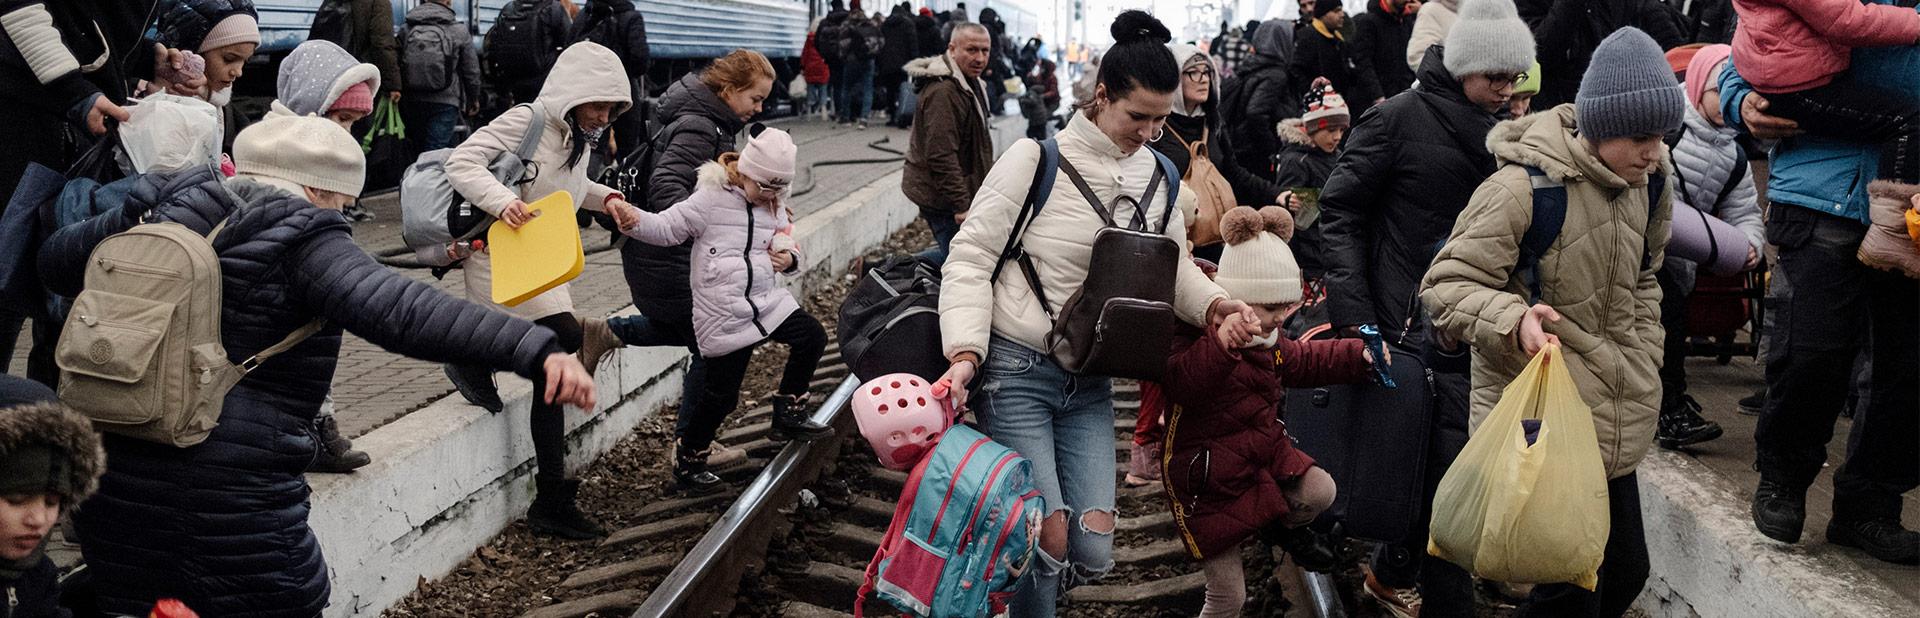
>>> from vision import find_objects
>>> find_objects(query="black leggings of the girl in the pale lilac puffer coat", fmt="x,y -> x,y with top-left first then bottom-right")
680,311 -> 828,451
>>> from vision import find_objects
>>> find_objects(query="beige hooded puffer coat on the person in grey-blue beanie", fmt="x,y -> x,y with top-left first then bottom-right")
1421,106 -> 1672,478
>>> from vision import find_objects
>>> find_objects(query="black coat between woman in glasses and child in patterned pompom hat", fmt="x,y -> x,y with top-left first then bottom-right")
1221,19 -> 1300,173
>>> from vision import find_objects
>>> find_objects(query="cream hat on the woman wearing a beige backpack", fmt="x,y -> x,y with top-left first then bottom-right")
234,115 -> 367,198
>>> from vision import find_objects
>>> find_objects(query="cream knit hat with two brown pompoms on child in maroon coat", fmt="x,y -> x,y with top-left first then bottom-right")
1213,205 -> 1304,305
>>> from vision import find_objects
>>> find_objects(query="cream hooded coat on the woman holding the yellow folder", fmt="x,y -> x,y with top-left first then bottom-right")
447,42 -> 634,321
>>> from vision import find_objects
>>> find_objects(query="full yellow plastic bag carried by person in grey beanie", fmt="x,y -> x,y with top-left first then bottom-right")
1427,345 -> 1613,589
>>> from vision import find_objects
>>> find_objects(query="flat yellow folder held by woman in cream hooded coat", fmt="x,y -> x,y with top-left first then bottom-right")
486,192 -> 588,307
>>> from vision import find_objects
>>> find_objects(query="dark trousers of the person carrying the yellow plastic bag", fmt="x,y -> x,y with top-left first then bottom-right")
1512,472 -> 1649,618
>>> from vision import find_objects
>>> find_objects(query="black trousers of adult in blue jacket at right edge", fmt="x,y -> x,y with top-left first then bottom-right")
1753,203 -> 1920,520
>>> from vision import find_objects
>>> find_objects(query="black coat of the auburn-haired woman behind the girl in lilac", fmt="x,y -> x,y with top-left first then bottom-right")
620,73 -> 745,320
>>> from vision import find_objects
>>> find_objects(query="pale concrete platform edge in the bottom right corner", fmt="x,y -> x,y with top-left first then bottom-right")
1634,451 -> 1920,618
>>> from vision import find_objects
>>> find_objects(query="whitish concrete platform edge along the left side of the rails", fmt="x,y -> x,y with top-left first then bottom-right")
307,121 -> 1025,618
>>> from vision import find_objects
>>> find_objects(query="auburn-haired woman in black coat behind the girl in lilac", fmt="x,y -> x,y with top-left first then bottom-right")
580,50 -> 774,489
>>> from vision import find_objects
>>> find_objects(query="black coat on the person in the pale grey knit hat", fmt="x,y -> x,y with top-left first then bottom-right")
1317,46 -> 1494,345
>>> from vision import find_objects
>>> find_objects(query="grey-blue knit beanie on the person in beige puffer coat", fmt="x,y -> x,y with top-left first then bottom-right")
1572,27 -> 1686,140
